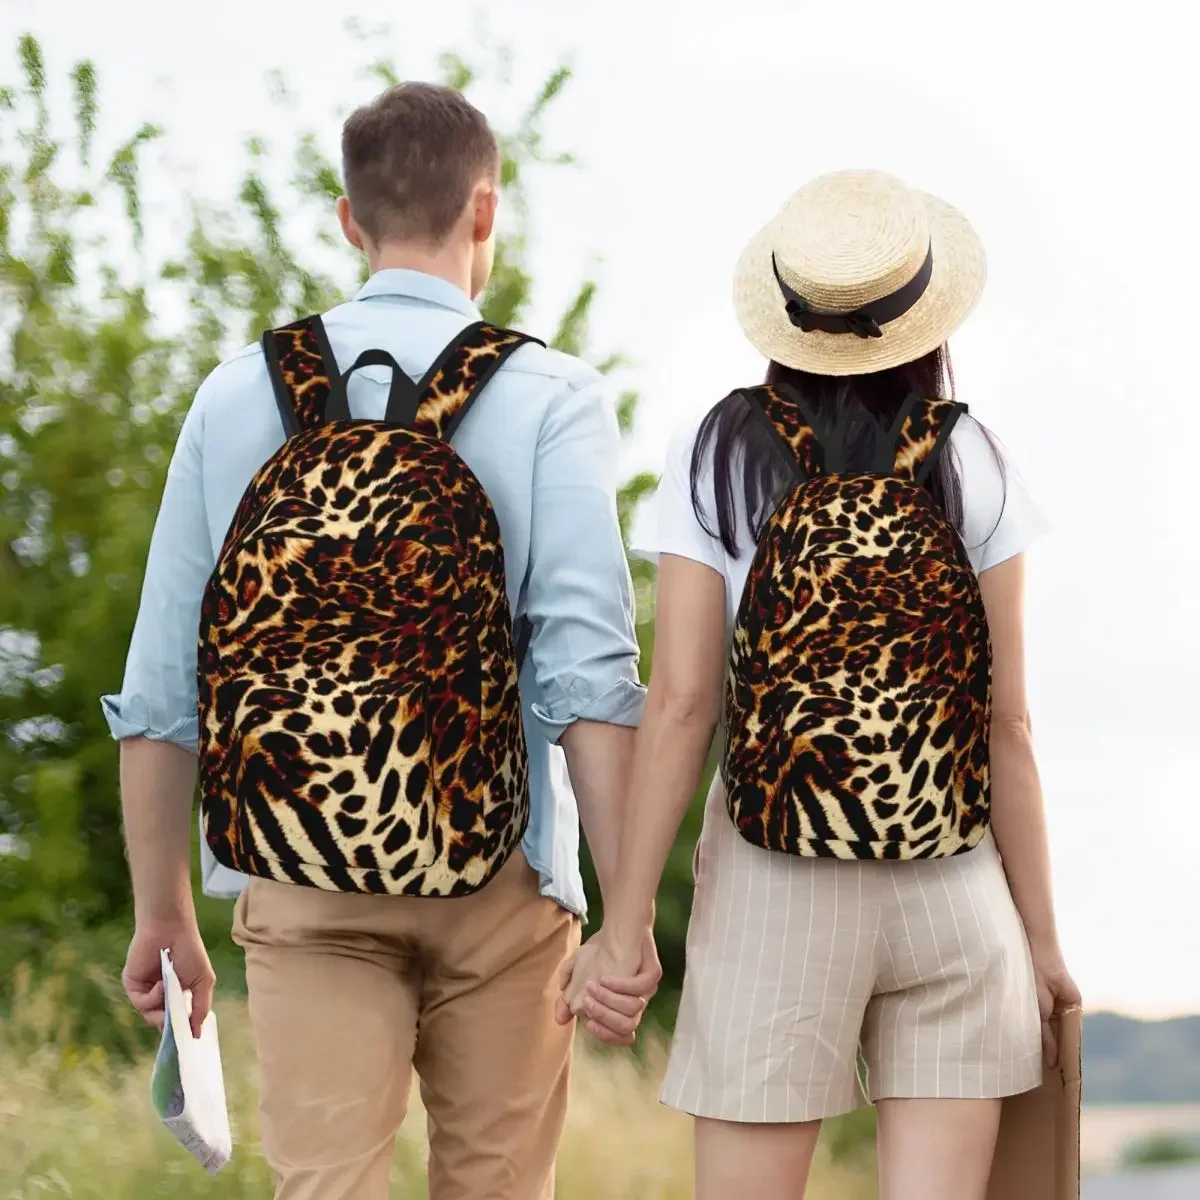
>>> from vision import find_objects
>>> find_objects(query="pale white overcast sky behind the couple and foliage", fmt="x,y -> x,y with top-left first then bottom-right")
0,0 -> 1200,1014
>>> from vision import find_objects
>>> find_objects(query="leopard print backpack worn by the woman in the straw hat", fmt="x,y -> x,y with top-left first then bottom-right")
721,386 -> 991,859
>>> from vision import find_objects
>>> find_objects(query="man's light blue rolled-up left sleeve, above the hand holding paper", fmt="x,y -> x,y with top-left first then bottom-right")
101,386 -> 214,751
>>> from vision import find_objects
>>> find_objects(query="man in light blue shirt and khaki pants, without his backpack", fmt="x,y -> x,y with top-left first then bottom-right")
104,84 -> 659,1200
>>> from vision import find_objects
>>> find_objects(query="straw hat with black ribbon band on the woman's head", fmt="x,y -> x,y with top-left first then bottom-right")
733,170 -> 986,376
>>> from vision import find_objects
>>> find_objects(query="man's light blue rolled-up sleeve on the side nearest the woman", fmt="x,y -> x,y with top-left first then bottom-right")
526,374 -> 646,742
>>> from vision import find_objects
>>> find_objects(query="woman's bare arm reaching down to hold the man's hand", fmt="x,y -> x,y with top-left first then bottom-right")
565,554 -> 725,1013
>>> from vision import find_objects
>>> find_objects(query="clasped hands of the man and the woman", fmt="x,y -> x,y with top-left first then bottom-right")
554,928 -> 662,1046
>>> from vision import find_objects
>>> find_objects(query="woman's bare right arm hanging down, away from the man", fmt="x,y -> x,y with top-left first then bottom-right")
979,554 -> 1080,1062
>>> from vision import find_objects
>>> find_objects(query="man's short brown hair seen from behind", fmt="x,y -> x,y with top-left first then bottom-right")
342,83 -> 500,244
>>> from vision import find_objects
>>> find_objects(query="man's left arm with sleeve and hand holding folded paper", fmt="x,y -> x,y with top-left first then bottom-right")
103,398 -> 215,1031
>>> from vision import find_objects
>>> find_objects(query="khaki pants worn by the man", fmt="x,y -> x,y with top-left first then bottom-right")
234,851 -> 580,1200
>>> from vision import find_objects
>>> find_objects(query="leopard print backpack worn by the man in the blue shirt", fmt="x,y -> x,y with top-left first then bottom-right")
198,317 -> 534,896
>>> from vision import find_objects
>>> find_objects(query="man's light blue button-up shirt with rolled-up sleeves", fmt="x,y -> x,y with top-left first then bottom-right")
103,270 -> 643,916
